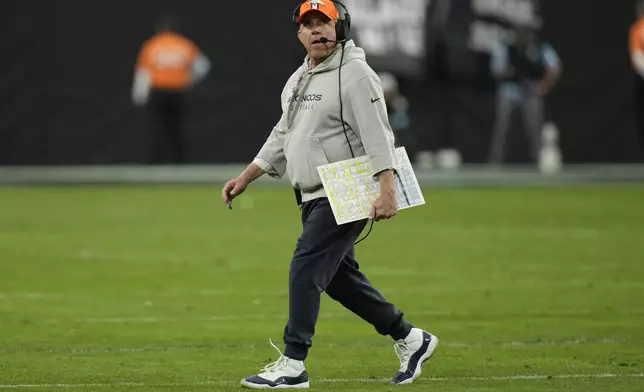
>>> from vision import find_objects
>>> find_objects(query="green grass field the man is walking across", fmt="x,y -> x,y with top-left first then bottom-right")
0,186 -> 644,392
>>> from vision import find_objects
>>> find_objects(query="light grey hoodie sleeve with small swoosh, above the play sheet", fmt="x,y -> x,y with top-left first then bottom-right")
344,75 -> 396,175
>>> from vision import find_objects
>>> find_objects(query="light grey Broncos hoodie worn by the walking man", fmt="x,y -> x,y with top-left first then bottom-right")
253,41 -> 396,202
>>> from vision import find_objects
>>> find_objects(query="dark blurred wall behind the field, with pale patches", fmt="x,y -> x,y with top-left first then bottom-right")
0,0 -> 644,165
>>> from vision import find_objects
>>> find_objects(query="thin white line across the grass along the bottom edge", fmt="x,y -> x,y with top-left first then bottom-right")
0,373 -> 644,389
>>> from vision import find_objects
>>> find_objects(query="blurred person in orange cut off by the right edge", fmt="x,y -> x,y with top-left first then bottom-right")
629,0 -> 644,150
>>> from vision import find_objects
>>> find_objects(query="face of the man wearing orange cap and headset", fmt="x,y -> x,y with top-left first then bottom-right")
297,11 -> 337,59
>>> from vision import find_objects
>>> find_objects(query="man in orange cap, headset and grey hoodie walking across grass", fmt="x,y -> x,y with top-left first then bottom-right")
222,0 -> 438,389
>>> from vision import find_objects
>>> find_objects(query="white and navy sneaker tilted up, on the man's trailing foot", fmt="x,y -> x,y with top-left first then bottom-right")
391,328 -> 438,384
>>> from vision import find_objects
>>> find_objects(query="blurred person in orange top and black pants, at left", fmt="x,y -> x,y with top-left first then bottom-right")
132,15 -> 210,163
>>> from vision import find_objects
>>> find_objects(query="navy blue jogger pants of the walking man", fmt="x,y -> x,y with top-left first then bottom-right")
284,198 -> 412,360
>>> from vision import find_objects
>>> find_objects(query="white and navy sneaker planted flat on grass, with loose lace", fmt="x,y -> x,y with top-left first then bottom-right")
241,340 -> 309,389
